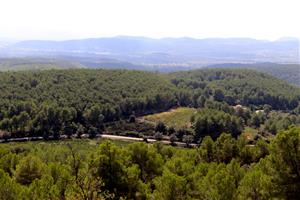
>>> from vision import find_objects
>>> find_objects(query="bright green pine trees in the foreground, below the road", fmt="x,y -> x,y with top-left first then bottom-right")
0,127 -> 300,200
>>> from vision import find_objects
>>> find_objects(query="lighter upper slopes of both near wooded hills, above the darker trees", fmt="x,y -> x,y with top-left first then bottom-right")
0,69 -> 300,113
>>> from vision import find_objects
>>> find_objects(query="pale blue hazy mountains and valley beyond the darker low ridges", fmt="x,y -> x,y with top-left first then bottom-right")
0,36 -> 299,67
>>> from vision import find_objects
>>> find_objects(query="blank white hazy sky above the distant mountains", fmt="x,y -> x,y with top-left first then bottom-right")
0,0 -> 300,40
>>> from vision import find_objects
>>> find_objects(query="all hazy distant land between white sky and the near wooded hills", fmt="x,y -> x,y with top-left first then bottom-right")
0,36 -> 300,86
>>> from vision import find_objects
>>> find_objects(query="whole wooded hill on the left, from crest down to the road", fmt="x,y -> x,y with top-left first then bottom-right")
0,70 -> 177,140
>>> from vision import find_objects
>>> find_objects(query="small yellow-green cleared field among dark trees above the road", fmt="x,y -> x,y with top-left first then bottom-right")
142,107 -> 197,128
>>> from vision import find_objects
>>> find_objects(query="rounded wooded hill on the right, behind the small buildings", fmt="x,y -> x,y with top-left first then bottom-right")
171,69 -> 300,110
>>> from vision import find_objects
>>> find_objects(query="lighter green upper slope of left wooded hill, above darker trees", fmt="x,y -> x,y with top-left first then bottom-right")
0,70 -> 175,109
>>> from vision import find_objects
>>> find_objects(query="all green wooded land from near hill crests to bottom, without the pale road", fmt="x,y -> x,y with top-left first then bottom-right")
0,69 -> 300,200
